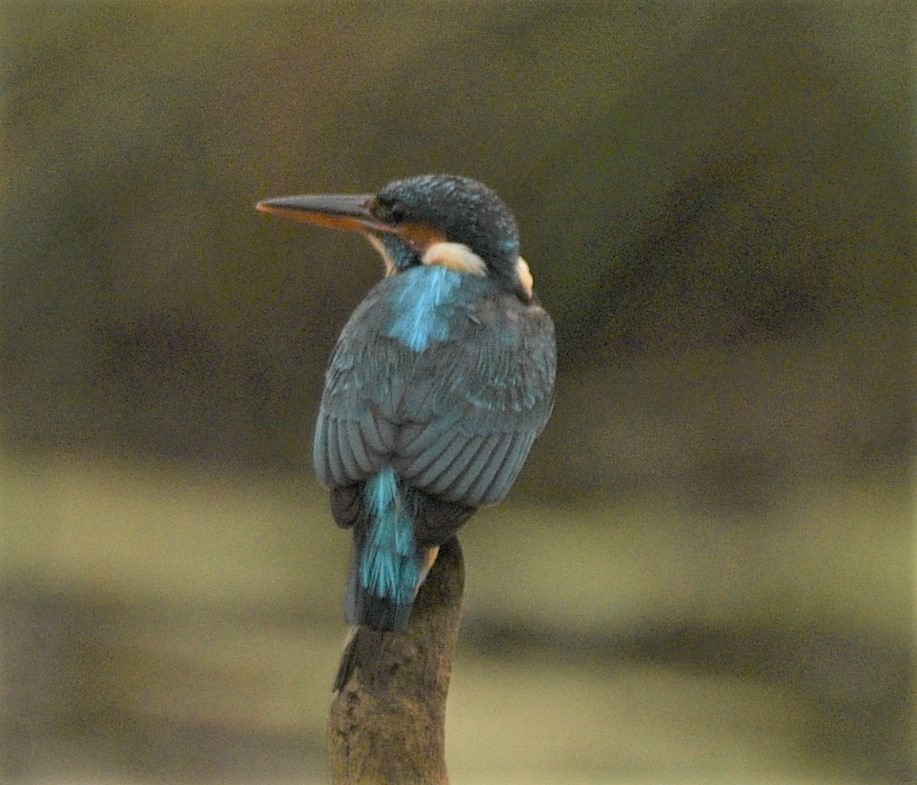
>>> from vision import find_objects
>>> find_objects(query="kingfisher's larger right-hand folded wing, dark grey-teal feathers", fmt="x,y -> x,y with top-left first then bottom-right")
394,300 -> 555,506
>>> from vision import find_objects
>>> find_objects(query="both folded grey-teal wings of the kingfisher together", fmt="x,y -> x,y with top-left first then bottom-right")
315,284 -> 555,507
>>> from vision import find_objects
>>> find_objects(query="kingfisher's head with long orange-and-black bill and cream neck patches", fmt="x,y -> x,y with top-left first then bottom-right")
257,174 -> 532,302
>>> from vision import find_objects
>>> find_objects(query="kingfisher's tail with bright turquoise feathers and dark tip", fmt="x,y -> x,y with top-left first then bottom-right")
344,468 -> 436,630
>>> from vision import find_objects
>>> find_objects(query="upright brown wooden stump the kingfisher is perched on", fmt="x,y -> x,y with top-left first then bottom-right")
328,538 -> 465,785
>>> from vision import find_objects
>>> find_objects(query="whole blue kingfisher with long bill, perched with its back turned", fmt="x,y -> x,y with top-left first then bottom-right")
257,174 -> 556,631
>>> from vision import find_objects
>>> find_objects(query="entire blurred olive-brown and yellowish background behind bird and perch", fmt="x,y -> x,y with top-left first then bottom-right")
0,0 -> 915,785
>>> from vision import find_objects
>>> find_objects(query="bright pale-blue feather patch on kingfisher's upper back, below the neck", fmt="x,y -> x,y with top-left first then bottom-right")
388,265 -> 462,352
